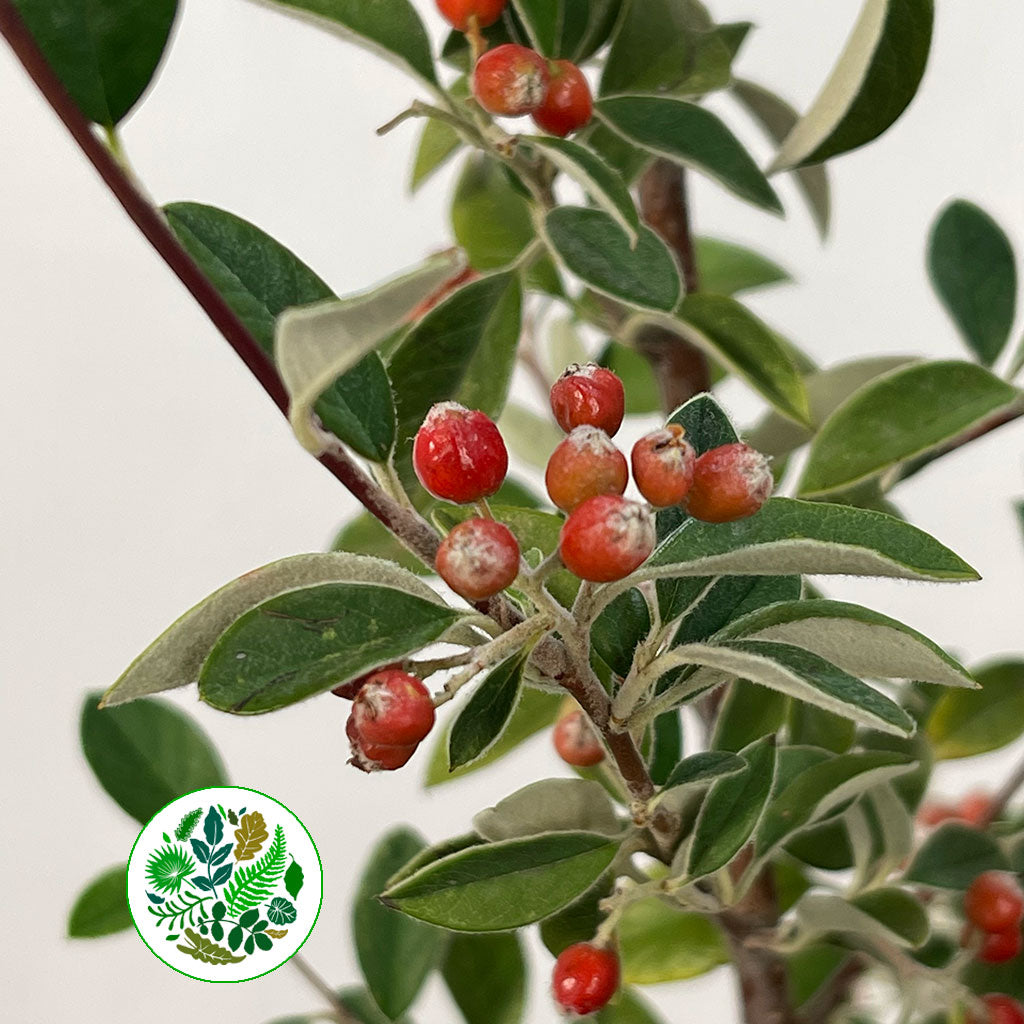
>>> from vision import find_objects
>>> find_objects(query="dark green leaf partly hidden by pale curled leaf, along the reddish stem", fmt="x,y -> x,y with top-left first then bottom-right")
164,203 -> 395,462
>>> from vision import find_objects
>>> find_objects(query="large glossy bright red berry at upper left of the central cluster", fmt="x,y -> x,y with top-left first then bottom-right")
413,401 -> 509,505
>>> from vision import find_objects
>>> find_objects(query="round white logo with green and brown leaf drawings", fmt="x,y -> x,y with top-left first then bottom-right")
127,785 -> 324,982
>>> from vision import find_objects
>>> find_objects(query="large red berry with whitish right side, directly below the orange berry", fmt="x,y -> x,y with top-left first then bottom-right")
558,495 -> 654,583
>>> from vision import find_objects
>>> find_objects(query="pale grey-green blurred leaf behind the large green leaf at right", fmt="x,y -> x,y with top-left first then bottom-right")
745,355 -> 914,459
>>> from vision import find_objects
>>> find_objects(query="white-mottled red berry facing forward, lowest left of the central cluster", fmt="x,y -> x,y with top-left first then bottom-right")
435,518 -> 519,601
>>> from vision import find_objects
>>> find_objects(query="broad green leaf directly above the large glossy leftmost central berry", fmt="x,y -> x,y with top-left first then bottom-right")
388,273 -> 522,466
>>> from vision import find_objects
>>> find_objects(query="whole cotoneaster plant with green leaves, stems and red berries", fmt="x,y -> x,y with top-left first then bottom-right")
0,0 -> 1024,1024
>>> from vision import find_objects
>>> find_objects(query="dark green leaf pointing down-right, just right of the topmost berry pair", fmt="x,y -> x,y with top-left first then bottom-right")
596,96 -> 782,213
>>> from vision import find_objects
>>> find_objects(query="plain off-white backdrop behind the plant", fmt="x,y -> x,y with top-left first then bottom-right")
0,0 -> 1024,1024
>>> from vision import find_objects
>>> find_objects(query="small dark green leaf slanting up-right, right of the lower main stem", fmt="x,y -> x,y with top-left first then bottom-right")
686,736 -> 777,880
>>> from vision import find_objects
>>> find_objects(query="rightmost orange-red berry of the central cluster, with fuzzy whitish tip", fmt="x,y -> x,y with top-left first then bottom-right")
686,442 -> 773,522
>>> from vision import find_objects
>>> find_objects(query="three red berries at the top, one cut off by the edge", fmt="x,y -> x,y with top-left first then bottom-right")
437,0 -> 594,138
